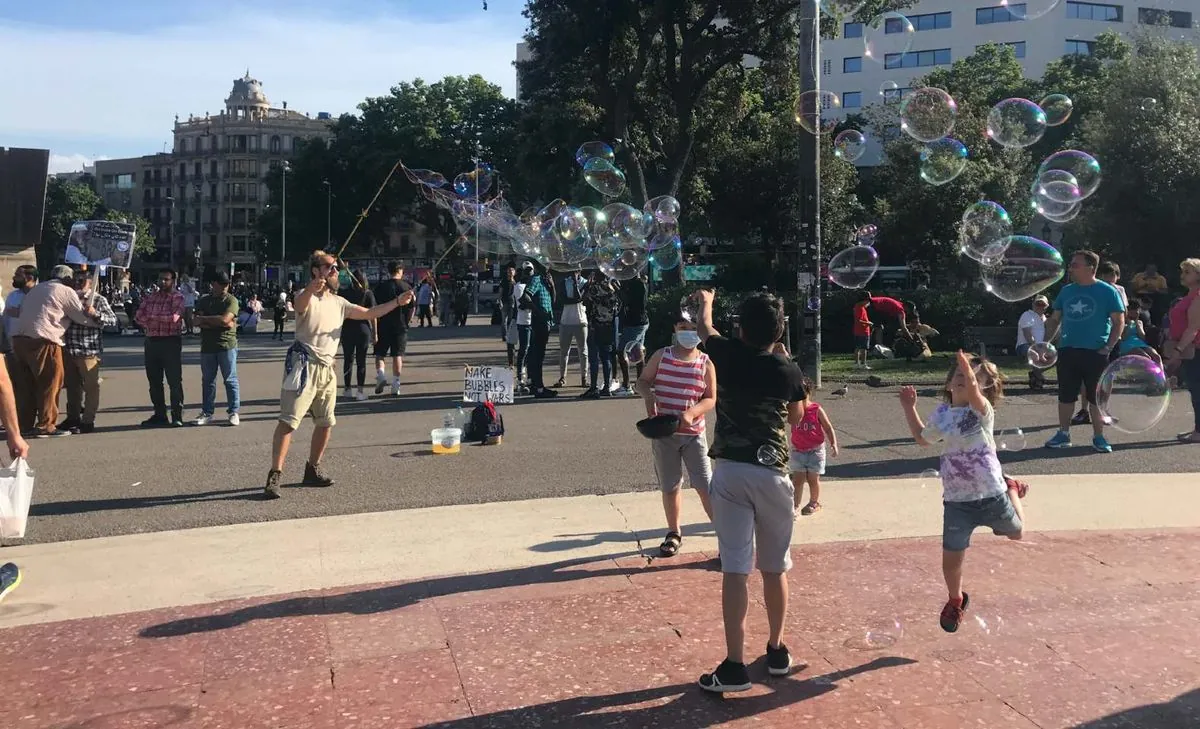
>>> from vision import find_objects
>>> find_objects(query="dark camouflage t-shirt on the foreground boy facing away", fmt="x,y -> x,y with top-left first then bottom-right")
703,336 -> 804,472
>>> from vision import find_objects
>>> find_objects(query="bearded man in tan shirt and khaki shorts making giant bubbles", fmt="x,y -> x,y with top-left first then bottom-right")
264,251 -> 415,499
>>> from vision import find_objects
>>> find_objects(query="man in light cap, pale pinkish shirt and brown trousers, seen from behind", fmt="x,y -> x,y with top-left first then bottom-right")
12,265 -> 97,438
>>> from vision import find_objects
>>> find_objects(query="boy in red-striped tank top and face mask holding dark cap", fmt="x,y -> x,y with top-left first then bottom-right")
637,314 -> 716,556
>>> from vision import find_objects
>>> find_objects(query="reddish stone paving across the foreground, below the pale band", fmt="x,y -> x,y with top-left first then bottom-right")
0,530 -> 1200,729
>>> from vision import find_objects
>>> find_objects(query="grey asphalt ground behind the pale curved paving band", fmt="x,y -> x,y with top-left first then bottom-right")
11,317 -> 1200,549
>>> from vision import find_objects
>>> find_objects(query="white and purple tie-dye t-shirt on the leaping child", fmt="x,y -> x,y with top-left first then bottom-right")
920,403 -> 1006,501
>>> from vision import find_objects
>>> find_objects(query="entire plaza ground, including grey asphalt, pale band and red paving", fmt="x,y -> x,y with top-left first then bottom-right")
0,324 -> 1200,729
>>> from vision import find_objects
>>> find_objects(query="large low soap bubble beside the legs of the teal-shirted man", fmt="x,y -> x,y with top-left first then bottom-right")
1096,355 -> 1171,433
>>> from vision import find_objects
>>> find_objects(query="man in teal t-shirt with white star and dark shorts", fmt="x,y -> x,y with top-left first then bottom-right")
1046,251 -> 1124,453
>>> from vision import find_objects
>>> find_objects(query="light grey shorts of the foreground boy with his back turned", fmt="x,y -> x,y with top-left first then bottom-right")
708,459 -> 796,574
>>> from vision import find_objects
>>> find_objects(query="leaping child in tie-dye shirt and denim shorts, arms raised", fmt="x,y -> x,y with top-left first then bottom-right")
900,351 -> 1025,633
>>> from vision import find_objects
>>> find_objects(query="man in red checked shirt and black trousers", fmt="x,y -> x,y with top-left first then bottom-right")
137,269 -> 184,428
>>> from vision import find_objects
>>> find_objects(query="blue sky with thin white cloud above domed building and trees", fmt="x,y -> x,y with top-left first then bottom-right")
0,0 -> 526,171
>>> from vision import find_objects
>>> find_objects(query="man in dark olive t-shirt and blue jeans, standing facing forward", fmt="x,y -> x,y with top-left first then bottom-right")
192,271 -> 241,426
